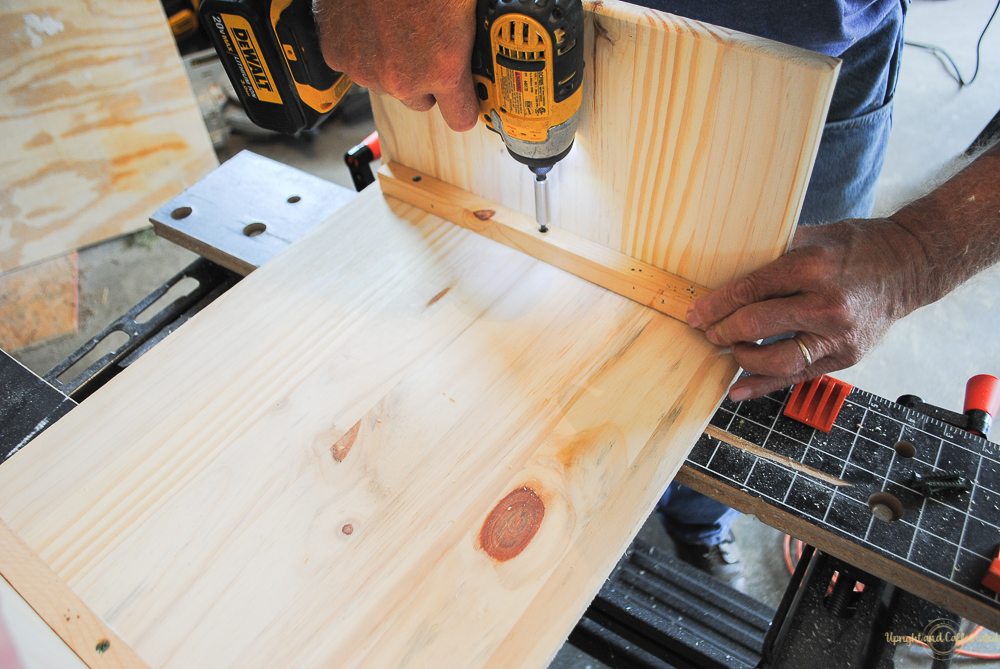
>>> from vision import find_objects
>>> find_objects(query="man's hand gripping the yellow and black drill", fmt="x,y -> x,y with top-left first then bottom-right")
313,0 -> 479,131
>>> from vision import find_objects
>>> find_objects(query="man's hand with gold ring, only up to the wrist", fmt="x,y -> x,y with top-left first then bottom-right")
687,219 -> 925,401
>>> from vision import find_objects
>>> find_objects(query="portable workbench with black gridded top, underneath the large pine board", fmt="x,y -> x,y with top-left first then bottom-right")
7,152 -> 1000,666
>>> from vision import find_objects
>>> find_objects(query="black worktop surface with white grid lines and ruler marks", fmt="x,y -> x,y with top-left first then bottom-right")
687,389 -> 1000,606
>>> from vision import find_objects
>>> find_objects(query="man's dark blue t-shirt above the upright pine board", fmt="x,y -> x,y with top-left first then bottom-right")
633,0 -> 900,56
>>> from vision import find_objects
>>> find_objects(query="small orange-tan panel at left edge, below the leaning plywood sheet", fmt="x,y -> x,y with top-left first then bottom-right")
0,251 -> 80,351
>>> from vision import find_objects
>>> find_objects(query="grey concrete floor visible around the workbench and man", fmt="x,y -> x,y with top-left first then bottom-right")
7,0 -> 1000,669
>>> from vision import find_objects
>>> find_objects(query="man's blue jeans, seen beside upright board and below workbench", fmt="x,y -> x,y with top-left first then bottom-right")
656,0 -> 906,546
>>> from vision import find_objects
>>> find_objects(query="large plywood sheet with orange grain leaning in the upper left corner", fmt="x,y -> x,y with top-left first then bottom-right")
0,0 -> 218,271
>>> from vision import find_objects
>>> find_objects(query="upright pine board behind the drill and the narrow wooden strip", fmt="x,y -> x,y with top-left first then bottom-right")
372,1 -> 839,289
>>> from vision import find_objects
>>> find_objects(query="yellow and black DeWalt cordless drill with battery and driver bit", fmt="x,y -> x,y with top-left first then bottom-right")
199,0 -> 583,232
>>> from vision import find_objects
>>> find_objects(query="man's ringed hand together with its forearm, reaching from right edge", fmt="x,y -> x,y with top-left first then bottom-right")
687,143 -> 1000,402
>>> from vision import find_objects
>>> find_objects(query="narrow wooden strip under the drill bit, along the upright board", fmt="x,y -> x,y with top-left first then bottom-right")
378,163 -> 711,321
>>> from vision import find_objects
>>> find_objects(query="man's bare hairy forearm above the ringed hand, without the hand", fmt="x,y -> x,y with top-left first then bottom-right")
889,143 -> 1000,311
